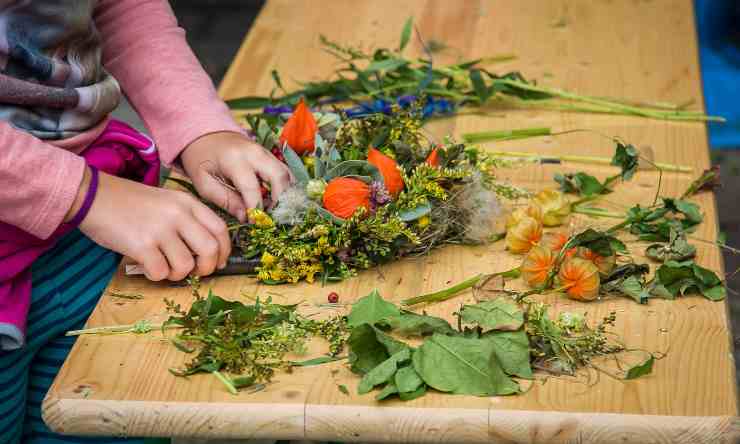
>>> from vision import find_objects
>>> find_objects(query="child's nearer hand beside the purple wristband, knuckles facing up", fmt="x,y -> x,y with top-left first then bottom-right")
80,172 -> 231,281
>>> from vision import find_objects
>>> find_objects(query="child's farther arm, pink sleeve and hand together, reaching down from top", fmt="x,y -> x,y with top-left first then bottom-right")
95,0 -> 290,221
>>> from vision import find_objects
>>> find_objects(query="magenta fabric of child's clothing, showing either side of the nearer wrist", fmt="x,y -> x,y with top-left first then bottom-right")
0,120 -> 160,349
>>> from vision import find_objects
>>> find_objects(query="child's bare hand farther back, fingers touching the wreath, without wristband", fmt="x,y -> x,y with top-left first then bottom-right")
180,132 -> 290,222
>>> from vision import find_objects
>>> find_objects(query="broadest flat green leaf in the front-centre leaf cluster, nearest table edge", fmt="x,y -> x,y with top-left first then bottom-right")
413,334 -> 519,396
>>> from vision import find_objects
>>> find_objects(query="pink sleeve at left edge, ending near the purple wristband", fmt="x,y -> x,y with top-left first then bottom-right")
0,122 -> 85,239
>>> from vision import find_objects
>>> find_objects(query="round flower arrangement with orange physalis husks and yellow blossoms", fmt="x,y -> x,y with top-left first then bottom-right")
221,100 -> 526,284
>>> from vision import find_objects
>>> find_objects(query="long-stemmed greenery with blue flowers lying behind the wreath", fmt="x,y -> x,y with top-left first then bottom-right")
227,18 -> 724,121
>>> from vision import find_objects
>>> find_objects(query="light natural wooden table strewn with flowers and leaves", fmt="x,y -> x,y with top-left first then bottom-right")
44,0 -> 740,443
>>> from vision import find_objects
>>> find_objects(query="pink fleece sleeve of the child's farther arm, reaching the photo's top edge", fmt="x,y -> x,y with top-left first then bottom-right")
95,0 -> 241,165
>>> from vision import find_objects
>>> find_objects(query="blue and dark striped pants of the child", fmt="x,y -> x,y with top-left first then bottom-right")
0,230 -> 152,444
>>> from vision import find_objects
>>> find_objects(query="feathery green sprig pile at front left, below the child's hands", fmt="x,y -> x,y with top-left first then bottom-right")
162,280 -> 348,393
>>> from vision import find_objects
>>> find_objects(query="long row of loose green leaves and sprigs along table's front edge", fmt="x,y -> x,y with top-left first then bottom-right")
162,285 -> 653,400
